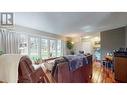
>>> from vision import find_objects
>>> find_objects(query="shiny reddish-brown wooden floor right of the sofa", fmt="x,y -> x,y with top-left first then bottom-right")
91,62 -> 117,83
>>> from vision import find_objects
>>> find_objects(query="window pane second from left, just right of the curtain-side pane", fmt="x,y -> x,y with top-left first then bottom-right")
30,37 -> 39,60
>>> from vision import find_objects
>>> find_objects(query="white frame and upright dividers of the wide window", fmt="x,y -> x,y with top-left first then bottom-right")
18,33 -> 64,59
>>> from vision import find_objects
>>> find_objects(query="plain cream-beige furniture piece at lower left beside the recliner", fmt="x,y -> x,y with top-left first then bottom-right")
0,54 -> 21,83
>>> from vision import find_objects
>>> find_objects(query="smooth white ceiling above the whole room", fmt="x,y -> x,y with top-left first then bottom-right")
15,12 -> 127,37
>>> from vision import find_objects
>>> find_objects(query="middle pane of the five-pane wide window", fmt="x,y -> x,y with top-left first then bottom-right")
41,39 -> 49,59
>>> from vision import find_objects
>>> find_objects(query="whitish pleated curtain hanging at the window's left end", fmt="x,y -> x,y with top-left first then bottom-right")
0,29 -> 18,54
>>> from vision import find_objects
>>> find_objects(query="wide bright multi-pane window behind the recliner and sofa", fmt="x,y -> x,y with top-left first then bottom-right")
18,34 -> 63,61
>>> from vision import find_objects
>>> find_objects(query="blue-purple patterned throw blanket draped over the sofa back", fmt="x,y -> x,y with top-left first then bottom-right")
64,54 -> 88,71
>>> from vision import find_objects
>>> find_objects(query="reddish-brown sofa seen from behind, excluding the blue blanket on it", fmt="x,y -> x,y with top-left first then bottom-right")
51,55 -> 92,83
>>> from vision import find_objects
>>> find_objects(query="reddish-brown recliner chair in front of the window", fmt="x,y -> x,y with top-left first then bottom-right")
18,56 -> 48,83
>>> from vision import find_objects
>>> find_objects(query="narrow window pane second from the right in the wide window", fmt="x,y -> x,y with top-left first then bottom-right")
49,40 -> 56,57
